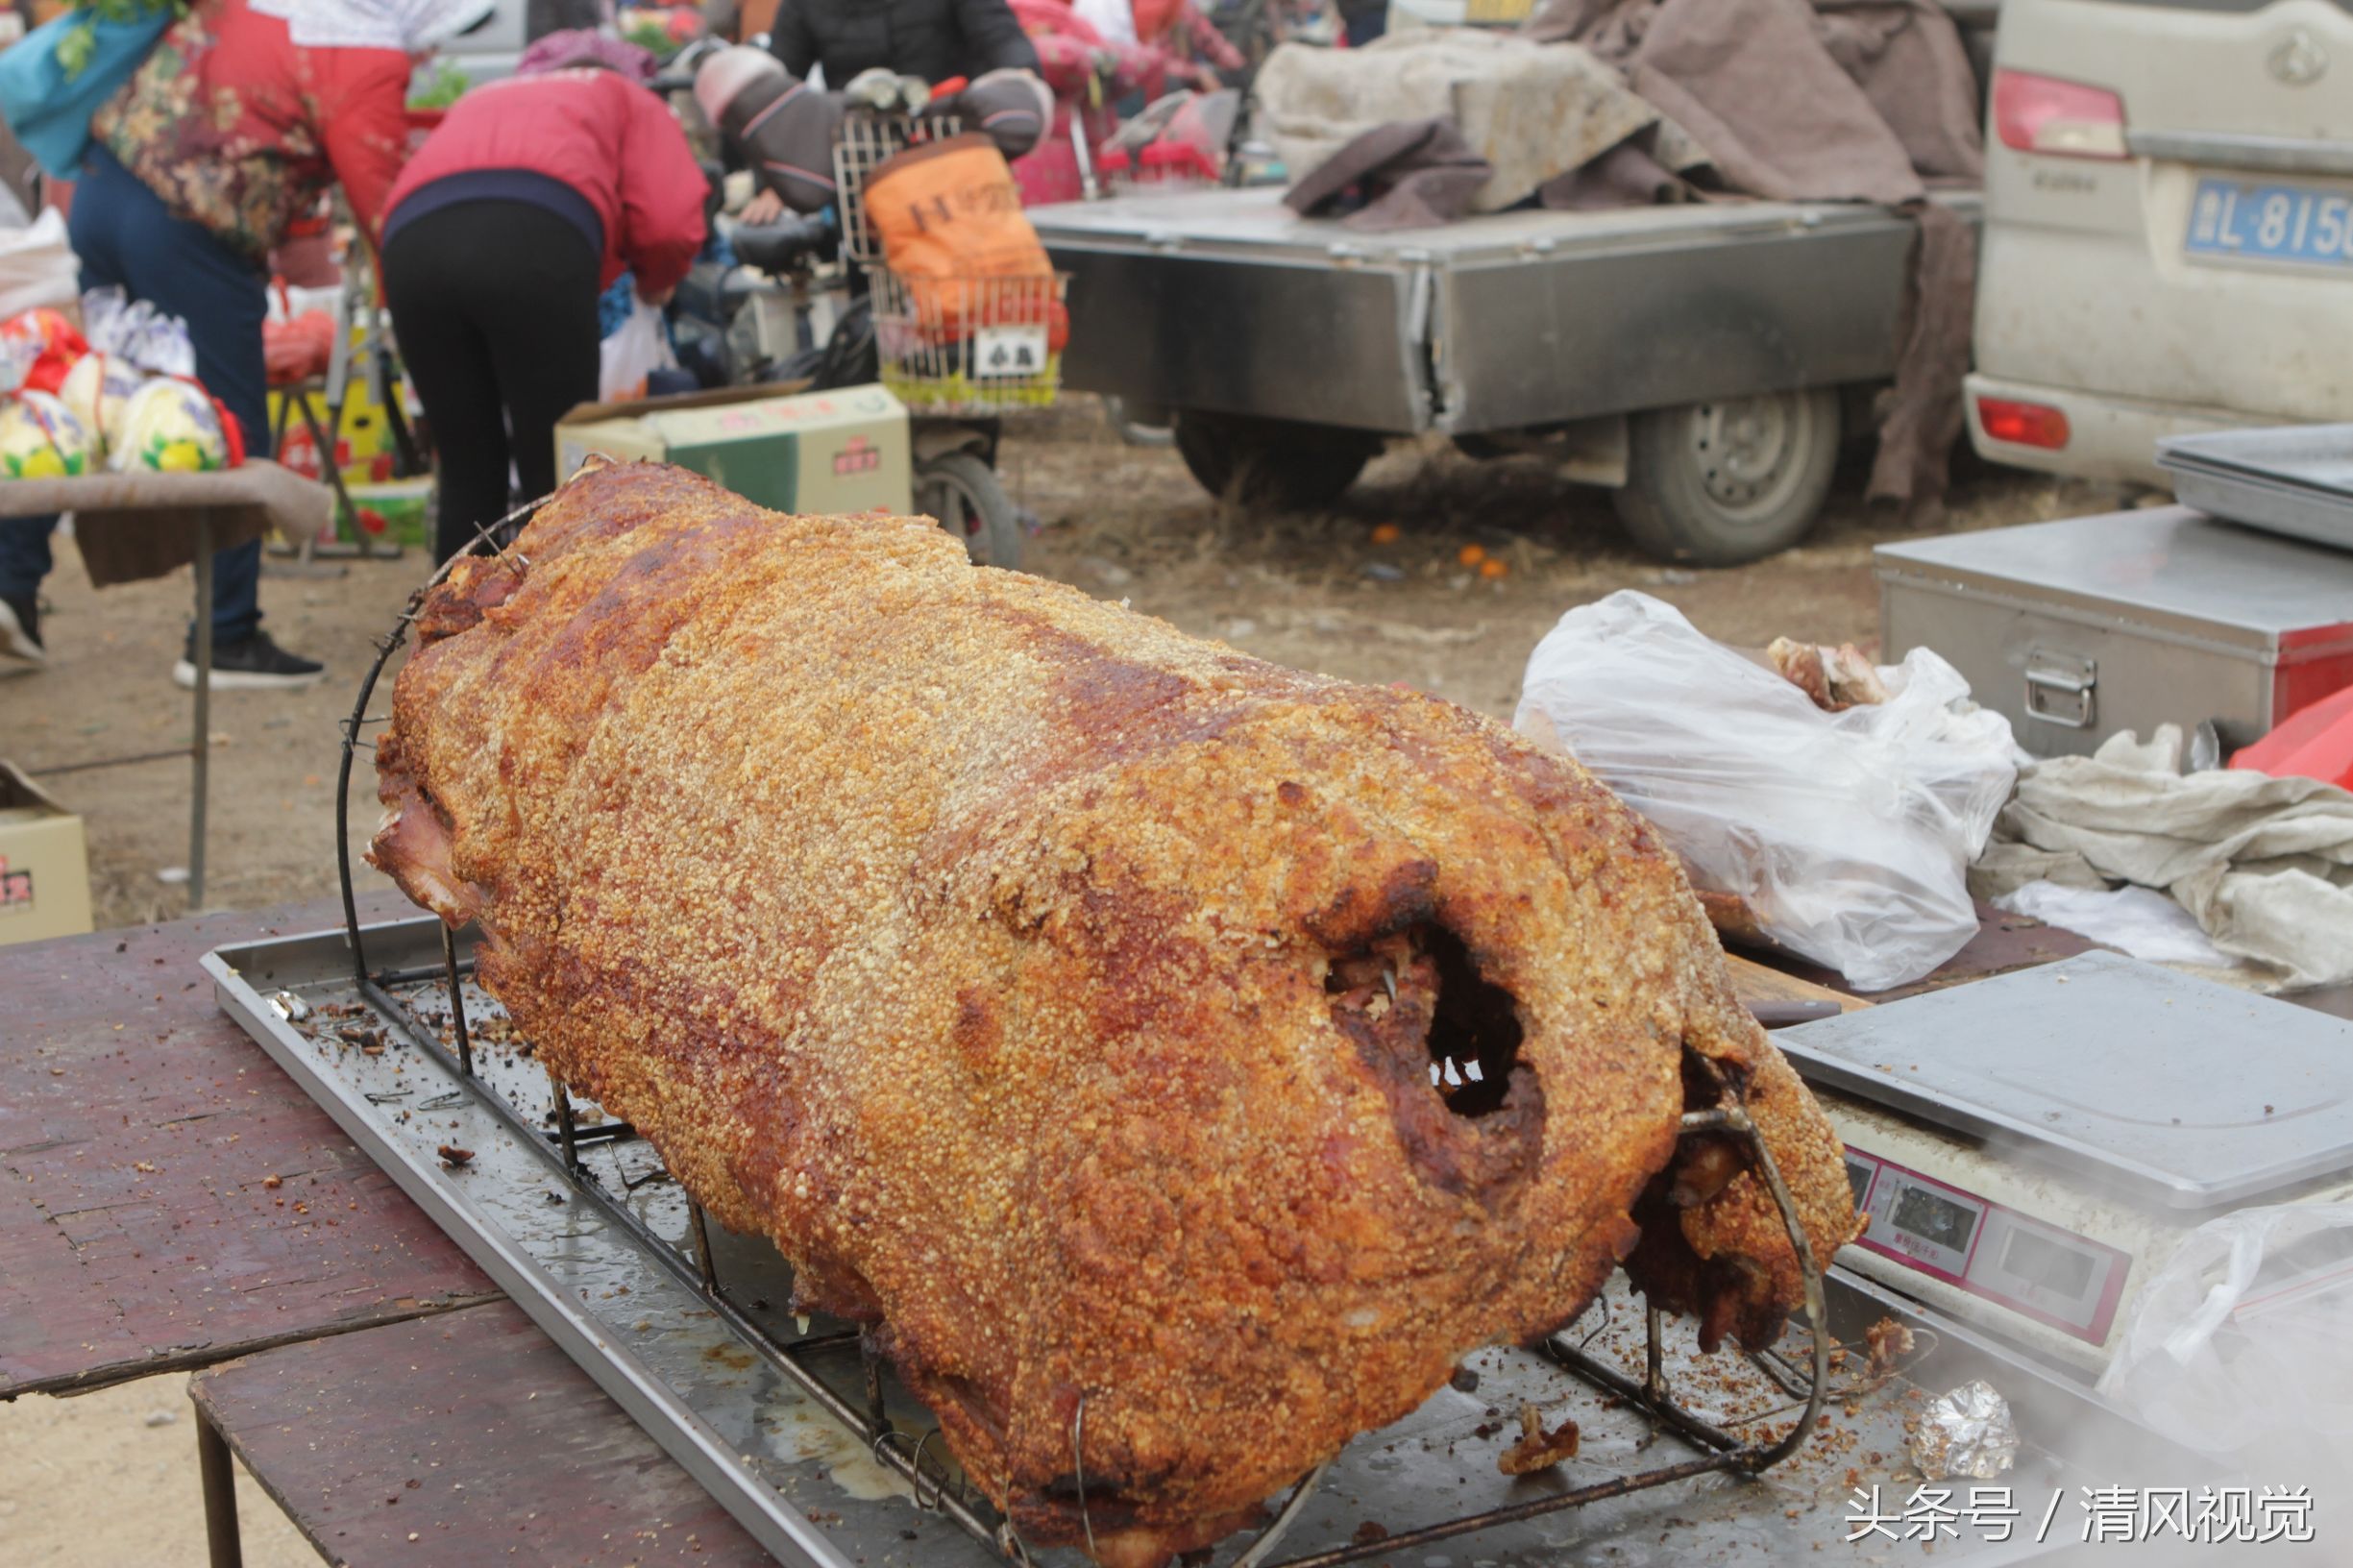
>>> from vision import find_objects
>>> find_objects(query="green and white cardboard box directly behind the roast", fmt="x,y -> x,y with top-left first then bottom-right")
555,386 -> 913,513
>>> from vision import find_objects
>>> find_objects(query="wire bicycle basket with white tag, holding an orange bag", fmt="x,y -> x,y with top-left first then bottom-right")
866,266 -> 1070,414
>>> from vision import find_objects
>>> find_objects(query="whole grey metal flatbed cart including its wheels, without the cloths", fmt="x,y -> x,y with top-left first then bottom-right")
1031,188 -> 1981,565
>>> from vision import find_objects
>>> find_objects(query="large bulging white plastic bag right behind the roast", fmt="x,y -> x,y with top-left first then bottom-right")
1518,591 -> 2014,992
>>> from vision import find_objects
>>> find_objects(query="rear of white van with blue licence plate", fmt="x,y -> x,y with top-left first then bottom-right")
1967,0 -> 2353,487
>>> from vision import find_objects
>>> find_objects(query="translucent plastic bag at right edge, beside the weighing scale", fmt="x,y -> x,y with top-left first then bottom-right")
2099,1203 -> 2353,1481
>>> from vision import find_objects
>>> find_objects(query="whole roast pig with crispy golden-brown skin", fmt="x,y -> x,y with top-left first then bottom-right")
372,464 -> 1854,1568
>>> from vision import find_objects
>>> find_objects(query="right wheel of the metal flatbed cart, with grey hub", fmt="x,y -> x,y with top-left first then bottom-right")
1616,386 -> 1838,568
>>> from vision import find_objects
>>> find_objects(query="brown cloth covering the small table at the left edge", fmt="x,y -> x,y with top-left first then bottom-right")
0,459 -> 334,589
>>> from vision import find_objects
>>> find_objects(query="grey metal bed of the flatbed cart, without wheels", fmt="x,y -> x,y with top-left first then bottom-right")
1031,188 -> 1979,435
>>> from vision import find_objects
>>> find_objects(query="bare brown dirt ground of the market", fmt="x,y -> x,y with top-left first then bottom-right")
0,403 -> 2116,1568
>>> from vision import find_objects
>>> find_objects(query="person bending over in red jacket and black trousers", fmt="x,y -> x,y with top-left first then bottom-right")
383,61 -> 708,560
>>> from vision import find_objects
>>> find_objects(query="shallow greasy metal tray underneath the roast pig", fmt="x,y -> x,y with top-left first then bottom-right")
205,919 -> 2212,1568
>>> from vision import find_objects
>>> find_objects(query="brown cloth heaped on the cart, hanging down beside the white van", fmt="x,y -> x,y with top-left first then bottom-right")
1527,0 -> 1984,523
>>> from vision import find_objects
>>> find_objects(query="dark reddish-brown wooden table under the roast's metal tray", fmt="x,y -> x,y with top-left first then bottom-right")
0,894 -> 2079,1568
